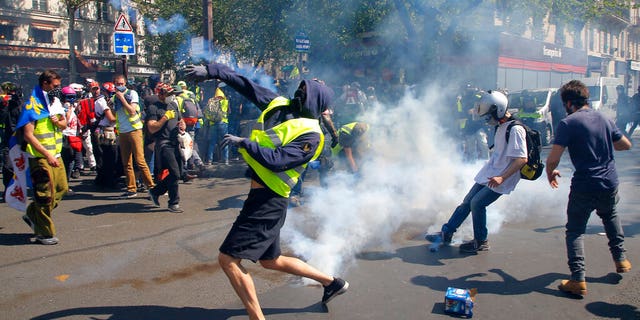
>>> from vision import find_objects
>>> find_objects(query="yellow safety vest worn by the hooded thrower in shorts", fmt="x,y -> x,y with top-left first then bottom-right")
238,97 -> 324,198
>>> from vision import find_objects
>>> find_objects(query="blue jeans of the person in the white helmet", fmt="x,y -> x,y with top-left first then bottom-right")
442,183 -> 502,241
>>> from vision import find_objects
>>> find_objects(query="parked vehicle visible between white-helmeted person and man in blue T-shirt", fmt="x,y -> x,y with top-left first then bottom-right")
508,88 -> 558,146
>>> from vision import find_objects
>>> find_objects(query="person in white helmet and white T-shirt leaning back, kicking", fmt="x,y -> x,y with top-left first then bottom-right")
425,90 -> 527,254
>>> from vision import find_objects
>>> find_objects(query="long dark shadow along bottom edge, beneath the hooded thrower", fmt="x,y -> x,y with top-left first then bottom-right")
31,303 -> 327,320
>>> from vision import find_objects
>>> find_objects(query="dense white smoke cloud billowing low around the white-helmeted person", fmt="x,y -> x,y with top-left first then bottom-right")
282,87 -> 569,275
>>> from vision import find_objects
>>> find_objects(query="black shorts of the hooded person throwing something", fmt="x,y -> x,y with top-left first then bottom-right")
220,188 -> 289,262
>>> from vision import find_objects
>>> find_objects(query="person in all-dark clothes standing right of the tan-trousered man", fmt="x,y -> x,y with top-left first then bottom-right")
145,83 -> 186,213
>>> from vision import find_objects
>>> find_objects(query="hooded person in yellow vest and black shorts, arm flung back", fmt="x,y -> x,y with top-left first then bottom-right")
186,63 -> 349,319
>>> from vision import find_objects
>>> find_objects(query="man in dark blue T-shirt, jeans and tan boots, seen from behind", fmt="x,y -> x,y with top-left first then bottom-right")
546,80 -> 631,295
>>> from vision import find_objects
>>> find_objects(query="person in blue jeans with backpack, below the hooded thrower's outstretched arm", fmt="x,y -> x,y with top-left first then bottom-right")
204,88 -> 229,165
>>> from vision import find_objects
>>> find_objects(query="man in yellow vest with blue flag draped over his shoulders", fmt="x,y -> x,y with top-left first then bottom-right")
16,70 -> 69,245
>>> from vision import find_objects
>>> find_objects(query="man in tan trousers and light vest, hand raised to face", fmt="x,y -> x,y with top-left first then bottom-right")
111,75 -> 155,198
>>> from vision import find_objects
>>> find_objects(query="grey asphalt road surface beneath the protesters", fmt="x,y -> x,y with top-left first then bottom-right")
0,147 -> 640,320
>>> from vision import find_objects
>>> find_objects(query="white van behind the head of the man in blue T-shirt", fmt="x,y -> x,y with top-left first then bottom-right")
580,77 -> 624,120
